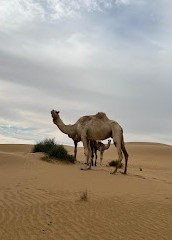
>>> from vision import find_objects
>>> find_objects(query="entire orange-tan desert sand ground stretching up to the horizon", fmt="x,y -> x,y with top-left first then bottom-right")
0,143 -> 172,240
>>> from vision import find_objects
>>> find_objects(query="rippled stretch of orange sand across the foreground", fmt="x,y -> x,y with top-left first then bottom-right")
0,188 -> 172,240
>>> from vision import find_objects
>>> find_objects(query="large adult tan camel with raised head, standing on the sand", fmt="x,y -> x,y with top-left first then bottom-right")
51,110 -> 128,174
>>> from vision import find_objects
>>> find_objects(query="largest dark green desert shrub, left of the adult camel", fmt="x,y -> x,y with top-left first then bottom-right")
33,139 -> 75,163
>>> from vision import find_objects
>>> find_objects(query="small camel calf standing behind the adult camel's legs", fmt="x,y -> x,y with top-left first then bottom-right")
90,140 -> 111,166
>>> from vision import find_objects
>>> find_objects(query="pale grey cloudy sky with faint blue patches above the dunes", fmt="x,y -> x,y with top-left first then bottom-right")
0,0 -> 172,145
